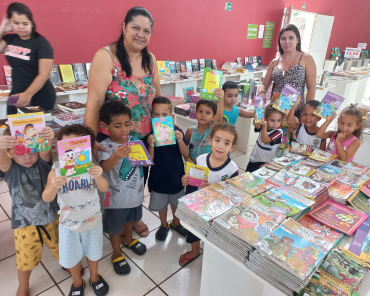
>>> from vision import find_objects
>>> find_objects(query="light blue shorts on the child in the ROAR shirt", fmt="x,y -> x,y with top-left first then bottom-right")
59,223 -> 103,268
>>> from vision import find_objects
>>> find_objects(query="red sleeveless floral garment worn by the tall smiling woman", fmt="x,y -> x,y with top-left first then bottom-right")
101,48 -> 155,139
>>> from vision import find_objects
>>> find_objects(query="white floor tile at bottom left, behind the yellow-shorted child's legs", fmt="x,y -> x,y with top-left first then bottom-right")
0,256 -> 54,295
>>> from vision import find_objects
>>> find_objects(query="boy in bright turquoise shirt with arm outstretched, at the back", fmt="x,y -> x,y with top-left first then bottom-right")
222,81 -> 254,125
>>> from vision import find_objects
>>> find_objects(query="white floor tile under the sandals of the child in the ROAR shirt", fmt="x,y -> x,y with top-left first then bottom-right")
59,257 -> 155,296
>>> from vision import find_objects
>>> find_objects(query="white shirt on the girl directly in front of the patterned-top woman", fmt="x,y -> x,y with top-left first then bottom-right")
249,126 -> 283,162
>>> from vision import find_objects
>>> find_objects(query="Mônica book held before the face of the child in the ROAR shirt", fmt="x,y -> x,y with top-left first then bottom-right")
57,136 -> 93,177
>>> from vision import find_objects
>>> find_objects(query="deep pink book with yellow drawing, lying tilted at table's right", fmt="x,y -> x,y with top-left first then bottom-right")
308,199 -> 368,235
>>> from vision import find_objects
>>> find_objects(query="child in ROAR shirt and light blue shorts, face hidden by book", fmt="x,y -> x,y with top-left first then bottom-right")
42,124 -> 109,296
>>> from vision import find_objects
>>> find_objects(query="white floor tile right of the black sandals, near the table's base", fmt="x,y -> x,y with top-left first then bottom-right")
124,230 -> 188,284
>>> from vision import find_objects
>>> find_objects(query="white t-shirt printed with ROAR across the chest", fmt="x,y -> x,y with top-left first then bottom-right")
57,174 -> 102,232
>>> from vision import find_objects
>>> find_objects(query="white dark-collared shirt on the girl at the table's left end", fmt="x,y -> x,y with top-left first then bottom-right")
196,153 -> 239,184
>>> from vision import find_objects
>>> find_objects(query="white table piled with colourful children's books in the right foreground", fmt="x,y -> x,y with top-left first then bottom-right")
176,153 -> 370,296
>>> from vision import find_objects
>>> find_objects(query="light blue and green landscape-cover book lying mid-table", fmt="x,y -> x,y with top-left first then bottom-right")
254,187 -> 313,217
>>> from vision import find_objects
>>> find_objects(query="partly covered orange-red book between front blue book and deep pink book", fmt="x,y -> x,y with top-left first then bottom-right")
297,213 -> 344,245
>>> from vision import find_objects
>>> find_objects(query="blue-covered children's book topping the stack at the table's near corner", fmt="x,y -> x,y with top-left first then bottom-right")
258,218 -> 333,280
